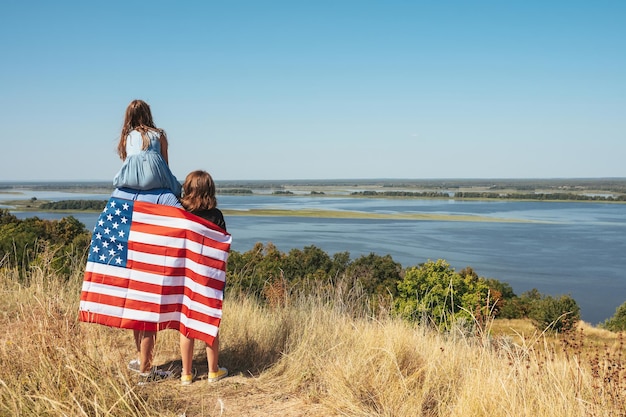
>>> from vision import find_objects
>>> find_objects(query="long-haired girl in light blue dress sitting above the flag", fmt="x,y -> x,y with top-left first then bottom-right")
113,100 -> 181,197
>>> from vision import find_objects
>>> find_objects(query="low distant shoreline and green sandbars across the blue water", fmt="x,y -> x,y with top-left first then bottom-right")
0,178 -> 626,216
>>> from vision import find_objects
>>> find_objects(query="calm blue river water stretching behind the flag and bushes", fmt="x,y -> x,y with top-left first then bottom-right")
0,192 -> 626,324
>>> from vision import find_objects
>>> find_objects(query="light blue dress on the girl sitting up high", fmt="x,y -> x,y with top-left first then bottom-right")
113,130 -> 181,197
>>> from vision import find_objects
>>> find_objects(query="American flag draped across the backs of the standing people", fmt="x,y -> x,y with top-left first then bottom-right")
79,197 -> 232,344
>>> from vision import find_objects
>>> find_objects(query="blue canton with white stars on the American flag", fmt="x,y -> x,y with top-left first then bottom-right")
87,197 -> 133,267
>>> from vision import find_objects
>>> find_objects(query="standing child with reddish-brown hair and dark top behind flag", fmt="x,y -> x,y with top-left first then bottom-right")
180,170 -> 228,385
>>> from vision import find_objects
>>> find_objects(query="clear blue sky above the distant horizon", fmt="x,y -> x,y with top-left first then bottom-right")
0,0 -> 626,181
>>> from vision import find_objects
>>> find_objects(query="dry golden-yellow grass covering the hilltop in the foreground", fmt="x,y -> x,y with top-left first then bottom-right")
0,254 -> 626,417
